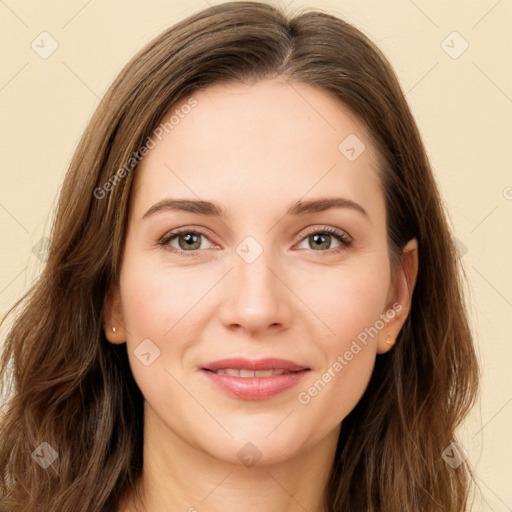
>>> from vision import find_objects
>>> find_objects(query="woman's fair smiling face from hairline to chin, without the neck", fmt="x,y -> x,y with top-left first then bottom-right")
107,80 -> 414,464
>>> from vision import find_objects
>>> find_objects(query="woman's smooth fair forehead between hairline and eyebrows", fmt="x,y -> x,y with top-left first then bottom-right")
132,79 -> 382,222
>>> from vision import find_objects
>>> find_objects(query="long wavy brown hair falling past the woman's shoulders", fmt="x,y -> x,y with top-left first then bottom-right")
0,2 -> 479,512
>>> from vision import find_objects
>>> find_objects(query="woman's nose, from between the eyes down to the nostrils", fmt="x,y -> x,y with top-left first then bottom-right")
220,247 -> 297,337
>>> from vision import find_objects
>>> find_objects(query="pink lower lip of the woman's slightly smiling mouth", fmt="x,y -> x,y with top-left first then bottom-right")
201,370 -> 309,400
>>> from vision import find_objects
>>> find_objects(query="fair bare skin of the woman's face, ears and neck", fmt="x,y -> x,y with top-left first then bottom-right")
104,79 -> 418,512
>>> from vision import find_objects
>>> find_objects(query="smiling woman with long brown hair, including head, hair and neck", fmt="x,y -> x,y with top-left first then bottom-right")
0,2 -> 478,512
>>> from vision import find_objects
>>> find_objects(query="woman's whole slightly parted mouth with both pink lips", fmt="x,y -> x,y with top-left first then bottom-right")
200,358 -> 310,400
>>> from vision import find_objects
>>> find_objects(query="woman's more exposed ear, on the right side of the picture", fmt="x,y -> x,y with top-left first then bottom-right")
377,238 -> 418,354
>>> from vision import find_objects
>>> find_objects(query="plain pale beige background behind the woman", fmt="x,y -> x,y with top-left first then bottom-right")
0,0 -> 512,511
